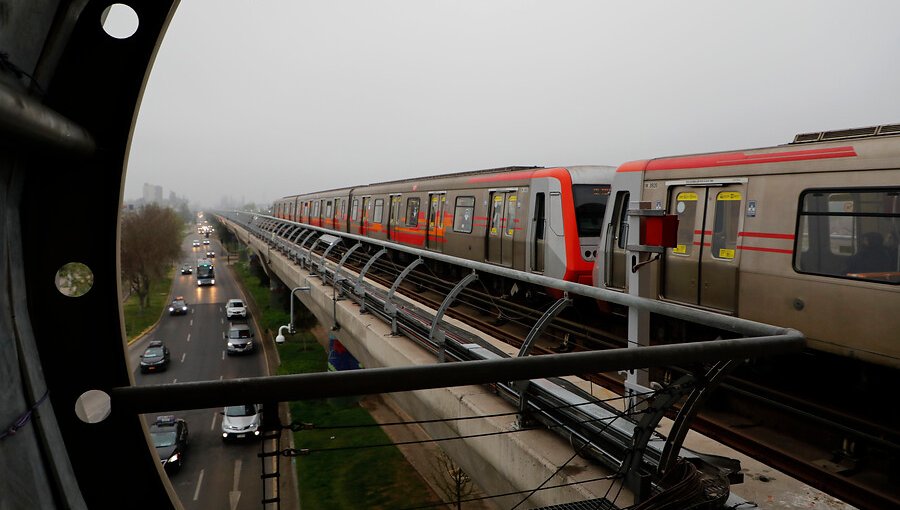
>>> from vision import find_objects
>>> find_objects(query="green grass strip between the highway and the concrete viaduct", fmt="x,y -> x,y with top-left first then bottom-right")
232,263 -> 434,510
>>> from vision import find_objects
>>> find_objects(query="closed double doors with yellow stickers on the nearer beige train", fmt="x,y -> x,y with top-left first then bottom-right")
662,180 -> 746,312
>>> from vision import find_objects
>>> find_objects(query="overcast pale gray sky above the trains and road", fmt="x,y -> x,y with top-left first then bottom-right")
125,0 -> 900,207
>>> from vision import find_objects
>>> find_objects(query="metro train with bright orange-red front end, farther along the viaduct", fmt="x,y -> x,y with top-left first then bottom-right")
274,166 -> 615,294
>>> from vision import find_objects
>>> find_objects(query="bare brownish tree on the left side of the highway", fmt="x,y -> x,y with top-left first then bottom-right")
121,204 -> 184,309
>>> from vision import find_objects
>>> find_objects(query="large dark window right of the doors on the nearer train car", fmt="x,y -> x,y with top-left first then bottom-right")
794,188 -> 900,284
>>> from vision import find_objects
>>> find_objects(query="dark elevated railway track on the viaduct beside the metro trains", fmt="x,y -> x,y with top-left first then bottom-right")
234,211 -> 900,508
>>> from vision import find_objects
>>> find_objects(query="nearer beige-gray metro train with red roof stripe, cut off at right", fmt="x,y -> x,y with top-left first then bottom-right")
593,125 -> 900,369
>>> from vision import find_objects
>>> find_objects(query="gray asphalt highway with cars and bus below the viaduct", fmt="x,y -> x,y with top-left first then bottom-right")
129,234 -> 271,510
